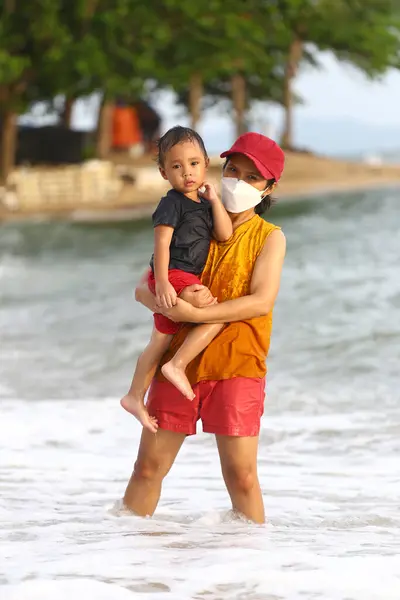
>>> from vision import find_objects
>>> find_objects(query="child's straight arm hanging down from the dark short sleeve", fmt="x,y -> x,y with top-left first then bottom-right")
154,225 -> 177,308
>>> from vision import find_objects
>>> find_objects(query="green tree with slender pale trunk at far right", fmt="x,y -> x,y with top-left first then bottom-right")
278,0 -> 400,148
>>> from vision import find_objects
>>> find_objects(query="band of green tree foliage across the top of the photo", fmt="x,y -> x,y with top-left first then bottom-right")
0,0 -> 400,115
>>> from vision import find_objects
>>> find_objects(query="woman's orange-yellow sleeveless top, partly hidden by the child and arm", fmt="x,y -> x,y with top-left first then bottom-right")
157,215 -> 279,385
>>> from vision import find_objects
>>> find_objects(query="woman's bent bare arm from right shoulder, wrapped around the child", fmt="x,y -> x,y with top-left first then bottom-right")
163,229 -> 286,323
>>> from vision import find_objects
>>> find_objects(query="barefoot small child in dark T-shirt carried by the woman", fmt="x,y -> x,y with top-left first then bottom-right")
121,127 -> 232,433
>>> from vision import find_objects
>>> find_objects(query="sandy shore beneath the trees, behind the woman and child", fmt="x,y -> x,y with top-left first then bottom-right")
0,152 -> 400,222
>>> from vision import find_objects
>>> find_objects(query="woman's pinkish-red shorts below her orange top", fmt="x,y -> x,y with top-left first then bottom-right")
147,377 -> 265,437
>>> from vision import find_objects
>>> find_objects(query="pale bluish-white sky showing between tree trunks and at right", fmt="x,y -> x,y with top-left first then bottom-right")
69,53 -> 400,152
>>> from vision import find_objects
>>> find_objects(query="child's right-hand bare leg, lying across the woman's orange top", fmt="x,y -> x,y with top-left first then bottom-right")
161,323 -> 224,400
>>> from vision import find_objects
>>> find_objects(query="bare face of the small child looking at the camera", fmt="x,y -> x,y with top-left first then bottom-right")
160,142 -> 209,195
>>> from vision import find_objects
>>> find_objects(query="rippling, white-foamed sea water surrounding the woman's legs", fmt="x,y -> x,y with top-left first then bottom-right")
0,188 -> 400,600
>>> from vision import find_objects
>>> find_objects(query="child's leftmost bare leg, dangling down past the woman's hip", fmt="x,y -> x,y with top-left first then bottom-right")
121,328 -> 172,433
